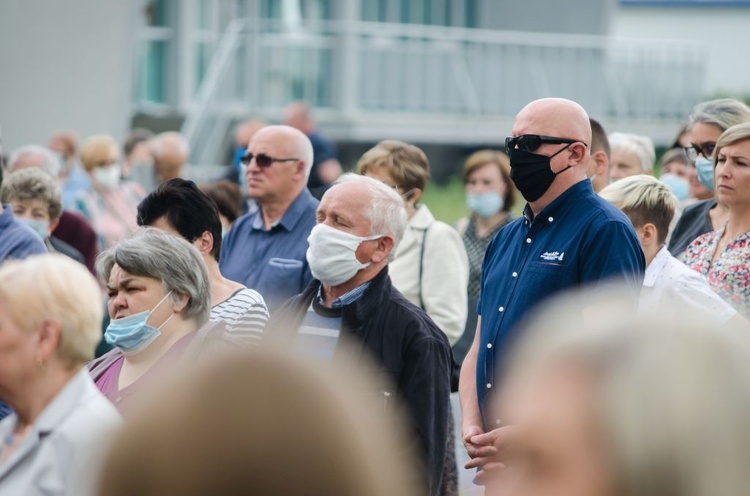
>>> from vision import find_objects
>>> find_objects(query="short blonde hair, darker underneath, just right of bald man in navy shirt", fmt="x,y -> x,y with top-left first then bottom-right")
599,174 -> 677,244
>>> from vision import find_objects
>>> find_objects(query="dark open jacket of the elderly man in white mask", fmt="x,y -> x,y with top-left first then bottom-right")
267,267 -> 453,494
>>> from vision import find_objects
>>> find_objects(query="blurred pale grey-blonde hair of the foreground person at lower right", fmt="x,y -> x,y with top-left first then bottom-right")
503,290 -> 750,496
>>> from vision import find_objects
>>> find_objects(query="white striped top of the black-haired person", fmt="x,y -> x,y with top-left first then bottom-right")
208,288 -> 268,344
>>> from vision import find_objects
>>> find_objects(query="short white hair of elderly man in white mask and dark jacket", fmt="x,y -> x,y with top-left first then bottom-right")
333,173 -> 407,262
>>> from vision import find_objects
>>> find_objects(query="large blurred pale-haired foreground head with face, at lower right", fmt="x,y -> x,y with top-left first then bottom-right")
487,286 -> 750,496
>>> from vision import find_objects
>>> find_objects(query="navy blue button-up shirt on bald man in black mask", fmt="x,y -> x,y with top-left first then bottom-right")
477,180 -> 646,420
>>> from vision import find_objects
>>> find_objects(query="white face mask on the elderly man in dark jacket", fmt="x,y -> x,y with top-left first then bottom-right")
307,224 -> 384,286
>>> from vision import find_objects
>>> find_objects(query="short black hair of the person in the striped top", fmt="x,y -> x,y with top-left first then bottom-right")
138,178 -> 221,261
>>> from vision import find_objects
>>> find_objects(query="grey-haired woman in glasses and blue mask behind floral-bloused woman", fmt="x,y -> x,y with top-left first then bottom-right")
668,98 -> 750,258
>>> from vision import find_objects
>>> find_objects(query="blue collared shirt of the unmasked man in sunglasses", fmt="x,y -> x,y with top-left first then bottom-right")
219,189 -> 319,312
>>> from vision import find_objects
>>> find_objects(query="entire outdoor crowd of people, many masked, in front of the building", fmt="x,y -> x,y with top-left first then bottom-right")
0,98 -> 750,496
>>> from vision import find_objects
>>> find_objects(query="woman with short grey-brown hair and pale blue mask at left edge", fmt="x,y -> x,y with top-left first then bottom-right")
0,168 -> 85,263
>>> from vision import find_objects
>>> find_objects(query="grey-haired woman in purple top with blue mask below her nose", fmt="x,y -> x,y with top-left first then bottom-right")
89,228 -> 224,412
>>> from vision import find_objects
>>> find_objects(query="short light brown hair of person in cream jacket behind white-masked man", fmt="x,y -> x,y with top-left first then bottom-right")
357,140 -> 430,192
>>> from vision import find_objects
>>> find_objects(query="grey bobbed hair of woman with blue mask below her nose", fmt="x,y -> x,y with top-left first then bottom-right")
96,227 -> 211,325
